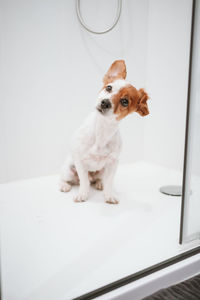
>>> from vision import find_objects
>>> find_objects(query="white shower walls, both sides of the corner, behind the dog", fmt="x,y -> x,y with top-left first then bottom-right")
0,0 -> 192,182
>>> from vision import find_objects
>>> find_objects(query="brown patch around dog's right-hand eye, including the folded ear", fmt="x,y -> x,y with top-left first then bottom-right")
111,85 -> 149,120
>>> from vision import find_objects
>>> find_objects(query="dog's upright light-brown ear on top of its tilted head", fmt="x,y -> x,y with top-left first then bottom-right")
103,60 -> 126,85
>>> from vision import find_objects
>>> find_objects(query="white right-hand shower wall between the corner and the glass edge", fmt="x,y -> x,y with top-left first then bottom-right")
144,0 -> 192,170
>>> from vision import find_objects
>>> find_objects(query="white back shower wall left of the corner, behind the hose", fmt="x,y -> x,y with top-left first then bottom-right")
0,0 -> 148,182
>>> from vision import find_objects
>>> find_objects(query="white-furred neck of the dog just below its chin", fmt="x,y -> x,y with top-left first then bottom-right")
95,112 -> 119,148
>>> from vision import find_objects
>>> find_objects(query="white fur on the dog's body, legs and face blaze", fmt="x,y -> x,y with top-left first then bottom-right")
60,79 -> 128,203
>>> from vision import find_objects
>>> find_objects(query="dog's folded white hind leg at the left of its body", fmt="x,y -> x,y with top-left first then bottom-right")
60,157 -> 79,192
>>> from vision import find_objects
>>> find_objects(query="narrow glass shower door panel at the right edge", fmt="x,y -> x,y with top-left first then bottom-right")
180,1 -> 200,243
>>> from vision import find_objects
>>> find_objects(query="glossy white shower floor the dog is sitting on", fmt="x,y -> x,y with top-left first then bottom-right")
0,162 -> 186,300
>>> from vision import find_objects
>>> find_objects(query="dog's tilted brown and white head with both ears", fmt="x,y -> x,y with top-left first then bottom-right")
96,60 -> 149,120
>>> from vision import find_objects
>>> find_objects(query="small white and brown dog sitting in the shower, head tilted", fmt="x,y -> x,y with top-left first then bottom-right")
60,60 -> 149,204
